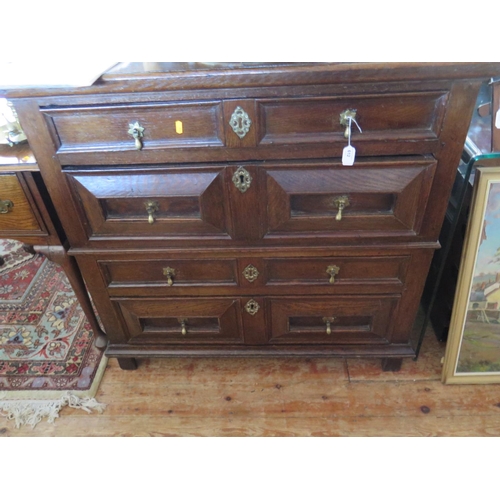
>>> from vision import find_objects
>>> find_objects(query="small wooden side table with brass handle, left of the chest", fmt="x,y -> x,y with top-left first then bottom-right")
0,144 -> 107,348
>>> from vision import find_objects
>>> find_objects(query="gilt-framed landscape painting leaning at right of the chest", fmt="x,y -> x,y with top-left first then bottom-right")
442,167 -> 500,384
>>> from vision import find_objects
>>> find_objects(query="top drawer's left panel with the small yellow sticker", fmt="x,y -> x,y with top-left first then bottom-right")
44,102 -> 223,153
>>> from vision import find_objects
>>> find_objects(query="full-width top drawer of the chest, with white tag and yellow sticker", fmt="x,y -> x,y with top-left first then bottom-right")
42,90 -> 448,165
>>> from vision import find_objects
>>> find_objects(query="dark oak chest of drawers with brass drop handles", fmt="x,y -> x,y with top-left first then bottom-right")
6,63 -> 500,369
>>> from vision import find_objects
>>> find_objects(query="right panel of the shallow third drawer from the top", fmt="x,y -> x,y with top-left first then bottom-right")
264,255 -> 410,293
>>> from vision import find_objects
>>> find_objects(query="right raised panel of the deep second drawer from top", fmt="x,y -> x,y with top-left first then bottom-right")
267,160 -> 436,237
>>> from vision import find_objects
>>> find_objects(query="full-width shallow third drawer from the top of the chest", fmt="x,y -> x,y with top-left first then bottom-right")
97,252 -> 411,297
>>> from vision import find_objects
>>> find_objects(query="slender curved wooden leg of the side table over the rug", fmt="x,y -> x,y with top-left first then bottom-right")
34,246 -> 108,349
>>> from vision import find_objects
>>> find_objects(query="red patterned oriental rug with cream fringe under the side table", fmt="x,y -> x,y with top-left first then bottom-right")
0,240 -> 107,427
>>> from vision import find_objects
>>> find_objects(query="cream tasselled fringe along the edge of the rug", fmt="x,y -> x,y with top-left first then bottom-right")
0,392 -> 106,429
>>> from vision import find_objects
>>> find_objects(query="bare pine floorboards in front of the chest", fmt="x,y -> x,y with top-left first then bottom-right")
0,326 -> 500,437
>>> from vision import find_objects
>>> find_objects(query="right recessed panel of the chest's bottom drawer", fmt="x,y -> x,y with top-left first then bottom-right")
269,296 -> 399,344
